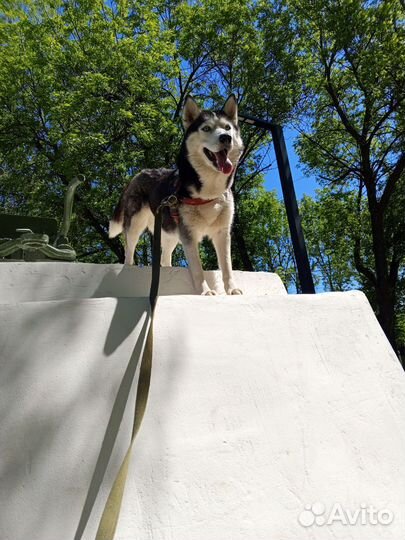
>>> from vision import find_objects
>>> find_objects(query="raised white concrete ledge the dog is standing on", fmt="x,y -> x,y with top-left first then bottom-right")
0,262 -> 287,303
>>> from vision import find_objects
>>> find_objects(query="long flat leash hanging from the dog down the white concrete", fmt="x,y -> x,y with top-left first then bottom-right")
95,195 -> 178,540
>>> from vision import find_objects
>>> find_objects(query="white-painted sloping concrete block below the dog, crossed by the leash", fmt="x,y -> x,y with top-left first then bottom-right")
0,263 -> 405,540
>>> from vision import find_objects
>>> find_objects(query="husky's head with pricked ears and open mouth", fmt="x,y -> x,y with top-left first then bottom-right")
183,94 -> 243,176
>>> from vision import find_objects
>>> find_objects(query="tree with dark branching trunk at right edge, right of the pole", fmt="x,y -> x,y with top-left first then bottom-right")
267,0 -> 405,348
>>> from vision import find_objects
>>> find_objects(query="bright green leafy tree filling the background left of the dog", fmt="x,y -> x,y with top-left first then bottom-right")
0,0 -> 178,261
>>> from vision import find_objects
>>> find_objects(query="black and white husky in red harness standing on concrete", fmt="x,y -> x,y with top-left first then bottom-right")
109,95 -> 243,295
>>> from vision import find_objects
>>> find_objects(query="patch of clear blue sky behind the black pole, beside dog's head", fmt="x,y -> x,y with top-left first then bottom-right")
265,127 -> 319,200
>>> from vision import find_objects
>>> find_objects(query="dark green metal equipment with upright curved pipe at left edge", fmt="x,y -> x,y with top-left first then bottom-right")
0,178 -> 81,261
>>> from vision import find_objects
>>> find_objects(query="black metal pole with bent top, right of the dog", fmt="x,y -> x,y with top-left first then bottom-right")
239,114 -> 315,294
